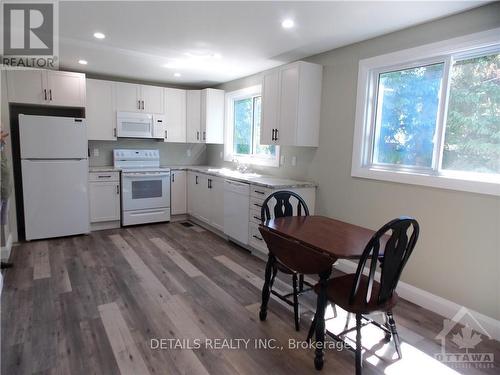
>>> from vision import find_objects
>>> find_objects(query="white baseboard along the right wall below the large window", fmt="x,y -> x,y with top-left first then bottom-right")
335,260 -> 500,341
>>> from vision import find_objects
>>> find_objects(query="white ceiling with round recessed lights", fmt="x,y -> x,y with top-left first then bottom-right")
59,1 -> 485,86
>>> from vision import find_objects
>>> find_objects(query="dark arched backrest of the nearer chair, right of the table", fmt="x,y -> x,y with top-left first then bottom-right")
349,217 -> 420,304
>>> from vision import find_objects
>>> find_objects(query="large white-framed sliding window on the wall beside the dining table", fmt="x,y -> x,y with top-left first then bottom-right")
352,27 -> 500,195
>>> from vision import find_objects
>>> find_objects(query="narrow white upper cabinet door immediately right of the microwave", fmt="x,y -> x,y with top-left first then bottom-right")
165,88 -> 186,143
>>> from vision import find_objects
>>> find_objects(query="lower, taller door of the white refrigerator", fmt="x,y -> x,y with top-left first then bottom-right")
21,160 -> 90,240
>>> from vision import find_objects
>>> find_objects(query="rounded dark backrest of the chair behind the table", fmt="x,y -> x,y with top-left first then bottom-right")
260,190 -> 309,223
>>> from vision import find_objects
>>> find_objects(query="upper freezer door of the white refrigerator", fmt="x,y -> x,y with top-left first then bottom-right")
19,115 -> 87,159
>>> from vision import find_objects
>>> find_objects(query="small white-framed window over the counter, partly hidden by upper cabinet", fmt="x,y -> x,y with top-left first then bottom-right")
224,86 -> 279,166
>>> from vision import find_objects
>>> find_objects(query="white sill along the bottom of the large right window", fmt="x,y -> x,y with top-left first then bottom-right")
351,167 -> 500,196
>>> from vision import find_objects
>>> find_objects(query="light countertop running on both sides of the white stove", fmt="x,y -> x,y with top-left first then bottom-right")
89,165 -> 318,189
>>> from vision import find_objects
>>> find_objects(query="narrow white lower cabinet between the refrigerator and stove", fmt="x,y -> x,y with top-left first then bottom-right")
89,172 -> 120,230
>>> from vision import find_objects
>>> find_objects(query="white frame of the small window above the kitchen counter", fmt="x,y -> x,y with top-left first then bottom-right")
224,85 -> 280,167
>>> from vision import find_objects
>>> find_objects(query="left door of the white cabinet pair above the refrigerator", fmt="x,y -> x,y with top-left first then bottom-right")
7,69 -> 44,104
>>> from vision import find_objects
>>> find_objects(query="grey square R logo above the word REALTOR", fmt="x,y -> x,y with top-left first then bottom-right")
3,3 -> 54,56
